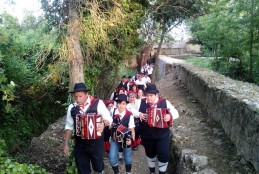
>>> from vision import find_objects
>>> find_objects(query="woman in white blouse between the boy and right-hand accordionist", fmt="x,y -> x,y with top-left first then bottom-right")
127,91 -> 142,150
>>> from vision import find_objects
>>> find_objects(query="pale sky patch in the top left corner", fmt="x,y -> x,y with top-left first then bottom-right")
0,0 -> 42,22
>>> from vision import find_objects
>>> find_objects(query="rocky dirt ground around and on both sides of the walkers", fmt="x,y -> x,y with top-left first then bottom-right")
19,67 -> 256,174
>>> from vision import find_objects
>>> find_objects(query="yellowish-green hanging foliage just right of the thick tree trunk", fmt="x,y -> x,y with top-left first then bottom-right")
81,0 -> 143,98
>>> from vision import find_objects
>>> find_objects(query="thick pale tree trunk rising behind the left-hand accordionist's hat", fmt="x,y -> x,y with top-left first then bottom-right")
67,0 -> 84,90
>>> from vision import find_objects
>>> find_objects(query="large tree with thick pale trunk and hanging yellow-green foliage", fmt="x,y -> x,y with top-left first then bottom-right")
40,0 -> 146,97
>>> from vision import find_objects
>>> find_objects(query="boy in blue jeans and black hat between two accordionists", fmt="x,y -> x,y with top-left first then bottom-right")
109,94 -> 135,174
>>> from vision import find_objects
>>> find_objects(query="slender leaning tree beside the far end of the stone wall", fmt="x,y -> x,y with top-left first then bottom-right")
138,0 -> 200,82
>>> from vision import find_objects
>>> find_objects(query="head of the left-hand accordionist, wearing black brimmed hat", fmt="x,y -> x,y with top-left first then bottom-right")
69,83 -> 90,105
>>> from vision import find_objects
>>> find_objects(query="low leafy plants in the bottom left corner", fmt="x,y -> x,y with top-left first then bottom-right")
0,139 -> 47,174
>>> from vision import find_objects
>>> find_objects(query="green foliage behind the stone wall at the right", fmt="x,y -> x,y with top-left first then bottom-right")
191,0 -> 259,84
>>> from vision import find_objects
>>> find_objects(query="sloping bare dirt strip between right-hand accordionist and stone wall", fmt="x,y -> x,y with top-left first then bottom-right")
157,70 -> 256,174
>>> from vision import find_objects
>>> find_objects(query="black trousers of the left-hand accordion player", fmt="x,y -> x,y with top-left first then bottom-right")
74,137 -> 104,174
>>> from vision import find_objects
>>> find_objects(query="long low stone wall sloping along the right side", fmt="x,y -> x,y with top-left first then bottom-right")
157,56 -> 259,171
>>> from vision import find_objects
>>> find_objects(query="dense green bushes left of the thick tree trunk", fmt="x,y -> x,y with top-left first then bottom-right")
0,11 -> 68,153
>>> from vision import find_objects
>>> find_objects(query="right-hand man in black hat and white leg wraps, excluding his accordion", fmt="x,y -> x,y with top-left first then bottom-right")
139,84 -> 179,174
